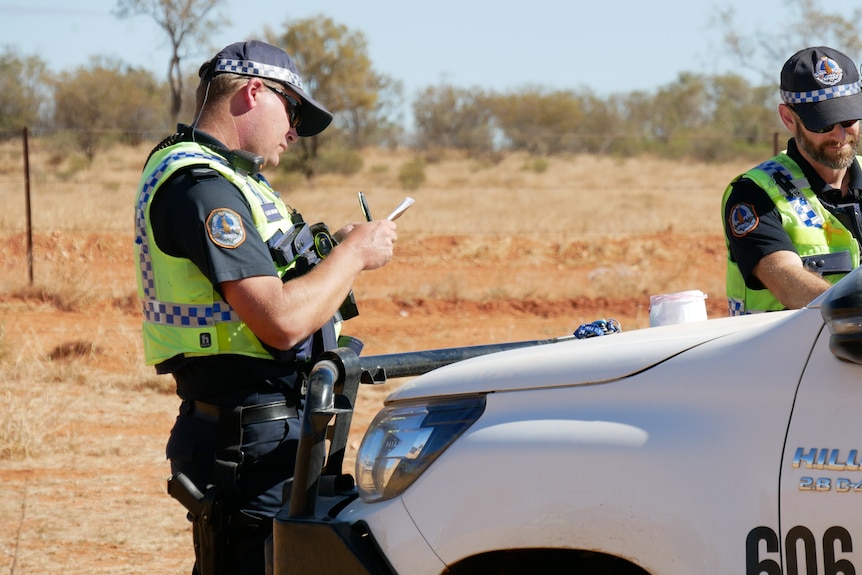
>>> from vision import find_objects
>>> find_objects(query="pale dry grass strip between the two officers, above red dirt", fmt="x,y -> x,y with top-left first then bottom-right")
278,151 -> 748,241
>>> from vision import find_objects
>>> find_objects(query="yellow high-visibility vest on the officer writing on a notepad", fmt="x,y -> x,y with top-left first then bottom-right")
135,142 -> 332,365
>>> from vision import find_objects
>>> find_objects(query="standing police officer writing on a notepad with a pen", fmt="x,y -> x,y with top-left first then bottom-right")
135,41 -> 396,575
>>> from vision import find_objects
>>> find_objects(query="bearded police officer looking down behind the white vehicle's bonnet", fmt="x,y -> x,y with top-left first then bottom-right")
722,46 -> 862,315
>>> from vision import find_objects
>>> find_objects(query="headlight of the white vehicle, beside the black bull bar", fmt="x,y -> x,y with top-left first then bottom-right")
356,396 -> 485,502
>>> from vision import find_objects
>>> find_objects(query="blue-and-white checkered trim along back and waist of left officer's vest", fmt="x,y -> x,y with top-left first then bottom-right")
135,148 -> 239,327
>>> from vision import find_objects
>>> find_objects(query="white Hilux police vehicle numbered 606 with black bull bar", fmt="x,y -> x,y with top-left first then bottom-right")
273,270 -> 862,575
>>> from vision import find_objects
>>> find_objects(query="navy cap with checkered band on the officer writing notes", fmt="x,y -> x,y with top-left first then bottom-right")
198,40 -> 332,137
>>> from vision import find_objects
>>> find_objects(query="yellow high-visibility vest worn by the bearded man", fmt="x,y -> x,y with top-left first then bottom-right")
721,152 -> 859,315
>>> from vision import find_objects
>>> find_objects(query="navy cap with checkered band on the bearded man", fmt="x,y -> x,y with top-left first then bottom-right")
781,46 -> 862,130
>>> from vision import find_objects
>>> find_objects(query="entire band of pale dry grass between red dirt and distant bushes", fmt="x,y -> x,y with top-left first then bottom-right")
0,140 -> 750,239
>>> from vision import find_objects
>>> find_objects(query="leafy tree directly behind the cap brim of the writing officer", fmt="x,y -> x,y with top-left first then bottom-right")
267,15 -> 401,178
